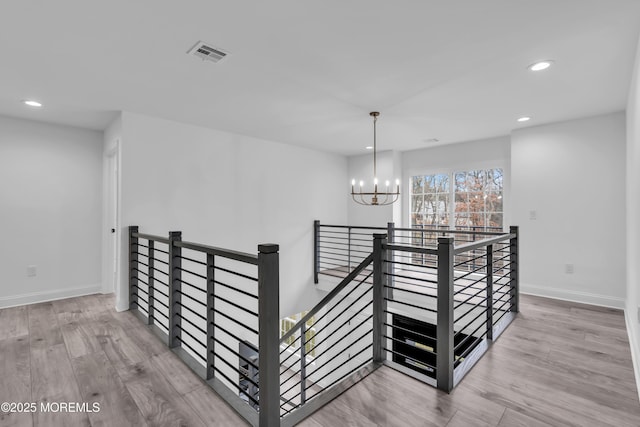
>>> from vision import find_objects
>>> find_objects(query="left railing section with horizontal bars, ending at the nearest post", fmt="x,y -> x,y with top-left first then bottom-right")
129,226 -> 280,426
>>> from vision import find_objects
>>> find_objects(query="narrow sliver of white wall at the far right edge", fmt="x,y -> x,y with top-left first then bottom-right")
626,31 -> 640,400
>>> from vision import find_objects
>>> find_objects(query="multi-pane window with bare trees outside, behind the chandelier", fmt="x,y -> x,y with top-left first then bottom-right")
411,168 -> 503,230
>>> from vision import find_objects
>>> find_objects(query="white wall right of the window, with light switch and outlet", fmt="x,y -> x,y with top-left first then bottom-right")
511,113 -> 626,308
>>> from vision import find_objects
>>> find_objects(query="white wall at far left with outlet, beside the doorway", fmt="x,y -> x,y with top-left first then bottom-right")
0,117 -> 102,307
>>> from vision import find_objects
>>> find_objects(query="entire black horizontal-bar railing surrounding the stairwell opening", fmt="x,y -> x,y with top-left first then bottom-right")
129,221 -> 518,426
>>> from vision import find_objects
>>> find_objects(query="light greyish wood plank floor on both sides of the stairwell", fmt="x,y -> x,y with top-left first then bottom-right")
0,295 -> 640,427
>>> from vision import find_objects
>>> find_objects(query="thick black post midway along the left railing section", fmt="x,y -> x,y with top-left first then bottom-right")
168,231 -> 182,348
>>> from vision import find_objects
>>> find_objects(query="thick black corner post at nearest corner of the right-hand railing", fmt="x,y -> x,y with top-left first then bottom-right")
436,237 -> 454,393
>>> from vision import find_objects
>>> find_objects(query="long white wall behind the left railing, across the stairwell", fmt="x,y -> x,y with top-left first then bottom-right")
118,113 -> 348,315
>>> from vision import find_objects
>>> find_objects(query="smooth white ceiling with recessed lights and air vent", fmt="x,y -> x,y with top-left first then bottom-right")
0,0 -> 640,154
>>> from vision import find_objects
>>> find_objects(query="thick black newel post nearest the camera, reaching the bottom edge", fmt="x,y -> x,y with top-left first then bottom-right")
258,244 -> 280,427
